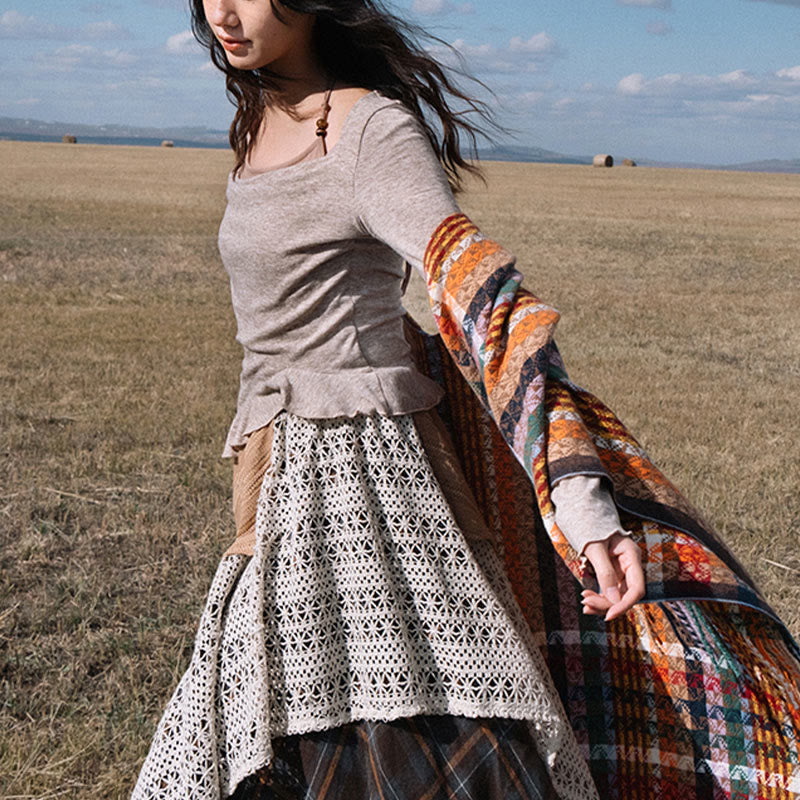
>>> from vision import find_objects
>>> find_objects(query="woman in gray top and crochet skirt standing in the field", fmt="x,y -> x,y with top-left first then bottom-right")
134,0 -> 800,800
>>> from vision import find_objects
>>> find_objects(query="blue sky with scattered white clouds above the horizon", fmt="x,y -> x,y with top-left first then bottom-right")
0,0 -> 800,164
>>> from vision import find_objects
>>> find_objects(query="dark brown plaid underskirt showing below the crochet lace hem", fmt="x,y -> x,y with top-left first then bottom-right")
232,715 -> 556,800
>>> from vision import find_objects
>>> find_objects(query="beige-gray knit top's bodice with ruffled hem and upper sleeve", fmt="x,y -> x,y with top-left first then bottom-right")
219,92 -> 459,456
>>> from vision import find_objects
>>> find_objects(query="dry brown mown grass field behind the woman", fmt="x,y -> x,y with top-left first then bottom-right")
0,142 -> 800,800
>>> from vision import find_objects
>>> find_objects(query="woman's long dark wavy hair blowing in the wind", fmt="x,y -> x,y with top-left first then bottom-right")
191,0 -> 494,190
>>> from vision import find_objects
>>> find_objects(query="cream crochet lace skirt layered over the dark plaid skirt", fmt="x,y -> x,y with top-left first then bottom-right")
133,413 -> 596,800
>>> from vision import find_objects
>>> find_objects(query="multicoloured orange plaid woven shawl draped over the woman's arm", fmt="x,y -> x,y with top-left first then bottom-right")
407,214 -> 800,800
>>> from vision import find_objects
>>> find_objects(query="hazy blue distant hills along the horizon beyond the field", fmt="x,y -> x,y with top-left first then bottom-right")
0,117 -> 800,174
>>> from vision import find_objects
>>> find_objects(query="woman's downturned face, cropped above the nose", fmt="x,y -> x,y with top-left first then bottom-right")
203,0 -> 314,75
